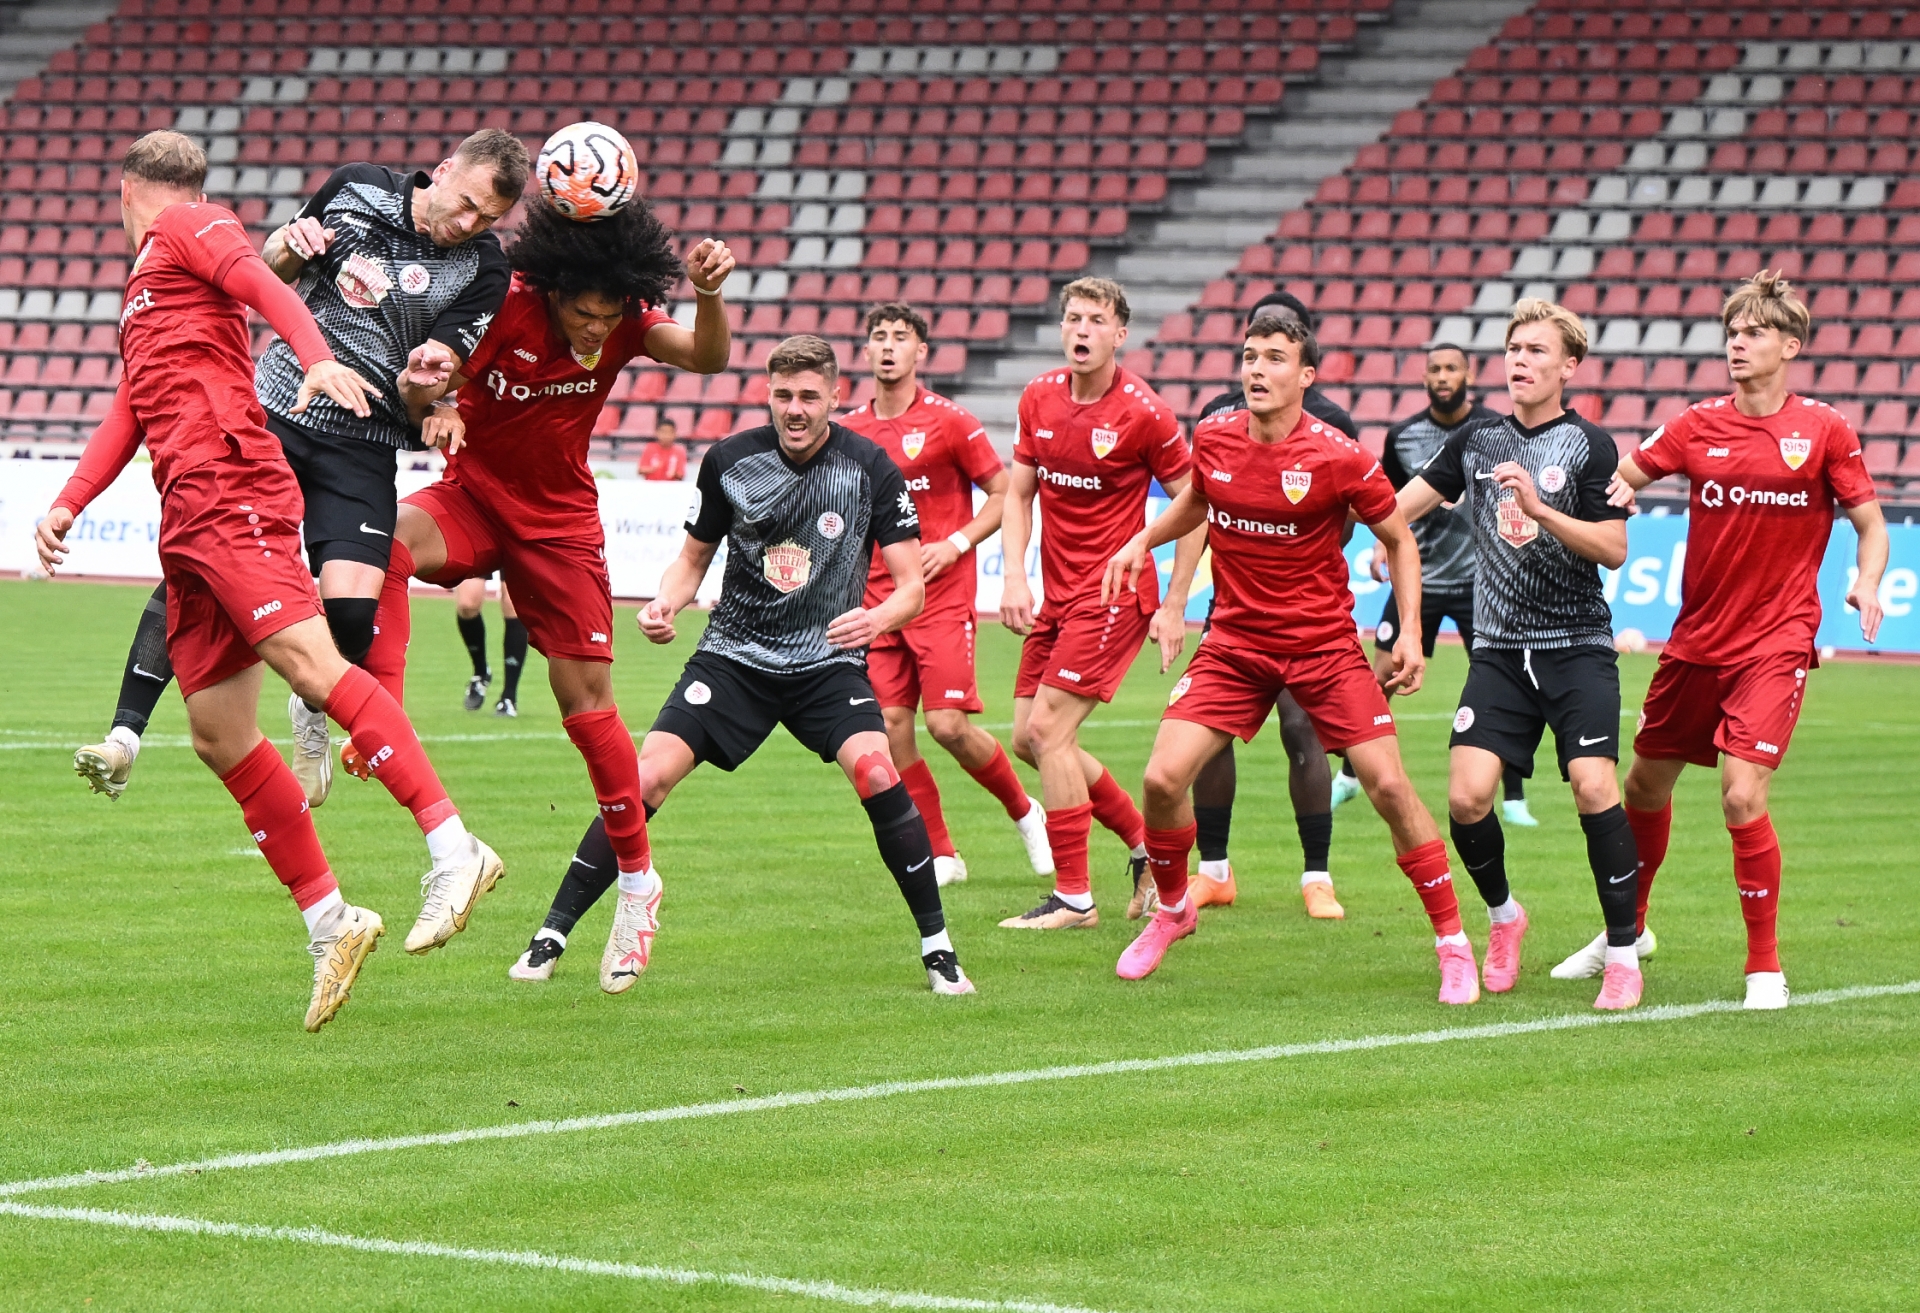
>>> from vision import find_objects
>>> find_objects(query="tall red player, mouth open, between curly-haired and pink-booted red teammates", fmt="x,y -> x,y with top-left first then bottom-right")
1000,278 -> 1188,929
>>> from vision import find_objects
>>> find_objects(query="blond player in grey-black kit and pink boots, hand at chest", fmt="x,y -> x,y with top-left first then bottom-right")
1400,298 -> 1642,1010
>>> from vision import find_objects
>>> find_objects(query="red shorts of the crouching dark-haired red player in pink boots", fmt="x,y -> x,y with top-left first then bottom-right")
1164,639 -> 1394,752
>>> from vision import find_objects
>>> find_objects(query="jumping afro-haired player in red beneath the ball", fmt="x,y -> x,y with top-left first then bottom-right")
367,200 -> 733,994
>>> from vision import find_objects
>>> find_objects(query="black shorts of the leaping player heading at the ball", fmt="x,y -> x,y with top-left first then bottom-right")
267,415 -> 399,574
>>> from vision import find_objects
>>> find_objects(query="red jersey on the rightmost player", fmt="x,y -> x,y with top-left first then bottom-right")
1632,383 -> 1874,666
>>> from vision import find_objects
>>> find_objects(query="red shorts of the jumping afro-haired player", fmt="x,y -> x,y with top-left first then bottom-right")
401,480 -> 612,660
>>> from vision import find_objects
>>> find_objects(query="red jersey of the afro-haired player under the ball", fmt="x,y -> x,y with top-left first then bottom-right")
447,276 -> 672,537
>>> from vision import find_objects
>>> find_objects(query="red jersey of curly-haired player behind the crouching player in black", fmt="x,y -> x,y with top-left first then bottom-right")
841,388 -> 1006,616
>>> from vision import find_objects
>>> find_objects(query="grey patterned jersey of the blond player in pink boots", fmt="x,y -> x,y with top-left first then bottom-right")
1421,415 -> 1626,649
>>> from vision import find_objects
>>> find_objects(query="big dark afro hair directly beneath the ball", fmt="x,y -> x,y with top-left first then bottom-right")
507,196 -> 685,311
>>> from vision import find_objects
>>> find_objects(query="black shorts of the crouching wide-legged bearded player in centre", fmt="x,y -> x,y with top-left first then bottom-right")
653,653 -> 887,770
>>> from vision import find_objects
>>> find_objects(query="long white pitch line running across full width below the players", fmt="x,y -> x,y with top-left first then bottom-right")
0,981 -> 1920,1200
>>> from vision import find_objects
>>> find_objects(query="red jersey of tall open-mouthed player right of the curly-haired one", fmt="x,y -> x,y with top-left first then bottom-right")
1014,367 -> 1190,610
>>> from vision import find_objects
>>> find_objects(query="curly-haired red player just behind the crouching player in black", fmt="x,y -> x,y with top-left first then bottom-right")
841,301 -> 1054,885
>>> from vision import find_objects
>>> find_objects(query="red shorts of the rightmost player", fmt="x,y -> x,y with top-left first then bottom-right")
1634,653 -> 1820,766
